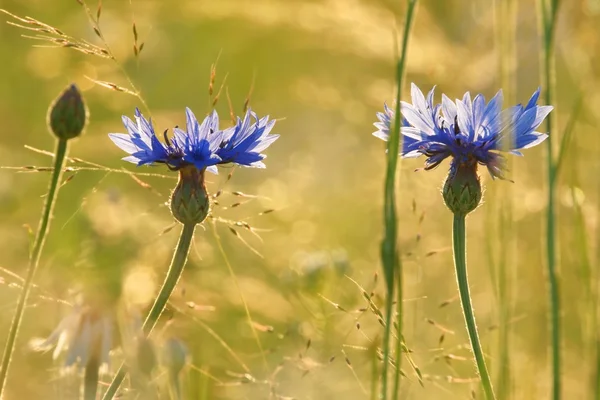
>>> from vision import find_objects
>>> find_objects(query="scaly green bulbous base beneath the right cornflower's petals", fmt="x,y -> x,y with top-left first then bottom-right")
442,159 -> 482,215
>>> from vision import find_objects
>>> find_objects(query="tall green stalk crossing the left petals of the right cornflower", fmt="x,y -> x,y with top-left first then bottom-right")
379,0 -> 417,399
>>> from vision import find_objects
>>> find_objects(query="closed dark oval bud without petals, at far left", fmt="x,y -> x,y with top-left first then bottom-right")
48,84 -> 88,140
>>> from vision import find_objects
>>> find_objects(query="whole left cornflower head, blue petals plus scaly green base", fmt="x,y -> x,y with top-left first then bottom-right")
109,108 -> 279,225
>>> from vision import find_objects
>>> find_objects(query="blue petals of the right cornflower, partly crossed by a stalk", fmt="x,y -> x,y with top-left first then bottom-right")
374,83 -> 553,179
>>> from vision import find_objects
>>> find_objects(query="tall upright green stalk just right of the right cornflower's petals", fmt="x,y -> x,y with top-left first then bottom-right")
540,0 -> 561,400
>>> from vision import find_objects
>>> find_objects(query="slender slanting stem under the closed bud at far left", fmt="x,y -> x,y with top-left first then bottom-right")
0,139 -> 68,399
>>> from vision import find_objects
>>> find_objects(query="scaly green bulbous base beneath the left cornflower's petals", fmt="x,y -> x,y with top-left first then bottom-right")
171,165 -> 210,225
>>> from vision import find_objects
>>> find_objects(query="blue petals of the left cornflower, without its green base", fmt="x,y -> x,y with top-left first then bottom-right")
109,108 -> 279,173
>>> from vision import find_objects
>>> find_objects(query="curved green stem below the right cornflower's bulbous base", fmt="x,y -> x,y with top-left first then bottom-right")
452,214 -> 496,400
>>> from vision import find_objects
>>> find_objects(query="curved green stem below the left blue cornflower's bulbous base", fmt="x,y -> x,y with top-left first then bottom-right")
102,224 -> 196,400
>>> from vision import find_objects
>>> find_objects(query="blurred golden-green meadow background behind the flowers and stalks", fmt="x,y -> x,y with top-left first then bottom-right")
0,0 -> 600,399
